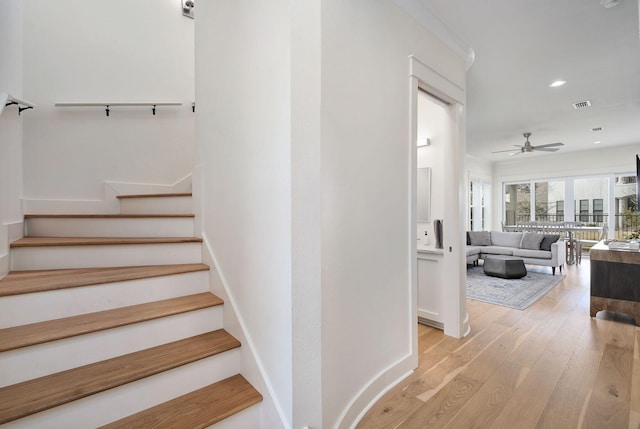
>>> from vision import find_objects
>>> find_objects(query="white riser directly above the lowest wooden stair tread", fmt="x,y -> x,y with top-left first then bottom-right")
2,349 -> 240,429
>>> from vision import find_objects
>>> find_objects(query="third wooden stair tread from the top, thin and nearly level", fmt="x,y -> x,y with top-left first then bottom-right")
11,237 -> 202,248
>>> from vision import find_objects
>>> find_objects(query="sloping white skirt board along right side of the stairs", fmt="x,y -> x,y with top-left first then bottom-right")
202,232 -> 289,429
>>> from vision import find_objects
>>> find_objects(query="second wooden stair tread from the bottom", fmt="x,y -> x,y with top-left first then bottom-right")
0,329 -> 240,424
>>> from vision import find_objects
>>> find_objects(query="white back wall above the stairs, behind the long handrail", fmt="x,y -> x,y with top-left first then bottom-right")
24,0 -> 195,200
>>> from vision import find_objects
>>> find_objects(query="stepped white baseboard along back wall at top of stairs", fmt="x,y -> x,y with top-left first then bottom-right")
22,174 -> 191,214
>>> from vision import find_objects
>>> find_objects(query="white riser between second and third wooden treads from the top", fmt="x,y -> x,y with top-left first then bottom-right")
26,217 -> 194,237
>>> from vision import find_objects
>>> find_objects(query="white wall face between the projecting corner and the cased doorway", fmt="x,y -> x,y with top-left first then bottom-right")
321,0 -> 465,428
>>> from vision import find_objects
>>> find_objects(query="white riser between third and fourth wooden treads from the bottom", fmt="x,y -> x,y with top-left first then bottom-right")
0,271 -> 209,328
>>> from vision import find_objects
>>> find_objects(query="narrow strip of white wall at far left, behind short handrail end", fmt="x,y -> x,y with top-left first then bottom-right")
0,0 -> 24,278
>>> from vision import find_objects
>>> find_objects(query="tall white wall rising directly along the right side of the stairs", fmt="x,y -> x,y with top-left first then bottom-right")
196,0 -> 293,428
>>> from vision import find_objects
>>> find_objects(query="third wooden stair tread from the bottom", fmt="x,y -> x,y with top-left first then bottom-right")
0,292 -> 223,352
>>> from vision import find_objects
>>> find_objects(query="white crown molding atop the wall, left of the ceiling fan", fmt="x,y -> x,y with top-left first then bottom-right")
393,0 -> 476,70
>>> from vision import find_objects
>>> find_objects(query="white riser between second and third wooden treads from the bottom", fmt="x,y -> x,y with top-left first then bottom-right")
0,306 -> 222,386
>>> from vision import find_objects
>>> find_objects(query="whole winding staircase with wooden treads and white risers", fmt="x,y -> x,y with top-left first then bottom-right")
0,194 -> 262,429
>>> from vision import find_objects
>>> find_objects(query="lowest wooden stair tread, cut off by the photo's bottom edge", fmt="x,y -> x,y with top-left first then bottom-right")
100,374 -> 262,429
